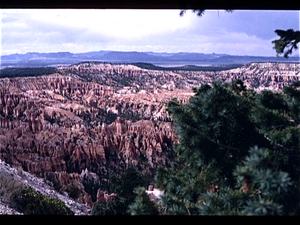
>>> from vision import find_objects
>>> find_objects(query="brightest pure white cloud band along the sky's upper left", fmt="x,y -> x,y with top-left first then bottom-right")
2,9 -> 190,39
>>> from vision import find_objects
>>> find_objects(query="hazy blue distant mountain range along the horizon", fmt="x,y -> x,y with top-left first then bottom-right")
1,51 -> 300,67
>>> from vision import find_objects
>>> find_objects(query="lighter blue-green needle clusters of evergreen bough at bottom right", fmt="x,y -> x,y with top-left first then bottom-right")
234,146 -> 292,215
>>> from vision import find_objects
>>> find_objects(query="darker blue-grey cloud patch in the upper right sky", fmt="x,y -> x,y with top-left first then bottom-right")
191,10 -> 299,39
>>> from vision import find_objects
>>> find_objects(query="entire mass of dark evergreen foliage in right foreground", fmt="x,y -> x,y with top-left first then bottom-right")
155,80 -> 300,215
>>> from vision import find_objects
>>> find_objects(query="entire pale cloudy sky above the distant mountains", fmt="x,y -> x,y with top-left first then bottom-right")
0,9 -> 300,56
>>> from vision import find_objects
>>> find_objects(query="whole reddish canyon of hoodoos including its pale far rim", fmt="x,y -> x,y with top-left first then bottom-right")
0,62 -> 300,211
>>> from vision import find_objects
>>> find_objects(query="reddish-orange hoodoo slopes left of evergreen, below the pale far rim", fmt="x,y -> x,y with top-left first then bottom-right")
0,67 -> 180,205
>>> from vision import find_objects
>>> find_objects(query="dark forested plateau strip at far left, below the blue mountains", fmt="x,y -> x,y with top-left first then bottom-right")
0,67 -> 58,78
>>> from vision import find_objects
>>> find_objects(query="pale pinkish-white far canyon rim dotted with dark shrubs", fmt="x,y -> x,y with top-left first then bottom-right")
59,62 -> 300,93
